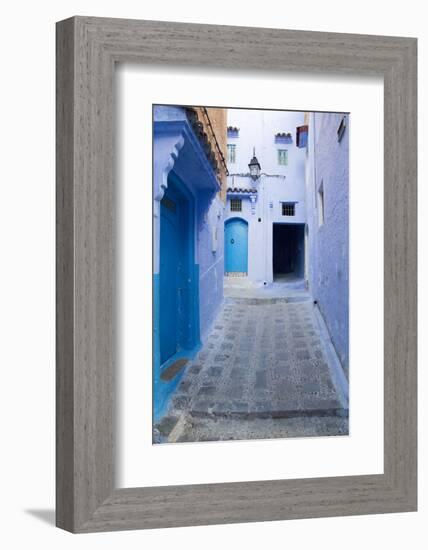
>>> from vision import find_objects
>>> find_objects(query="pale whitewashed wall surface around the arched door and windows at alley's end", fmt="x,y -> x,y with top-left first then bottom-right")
225,109 -> 306,283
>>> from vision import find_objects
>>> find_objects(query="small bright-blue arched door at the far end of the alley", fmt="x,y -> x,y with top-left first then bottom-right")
224,219 -> 248,273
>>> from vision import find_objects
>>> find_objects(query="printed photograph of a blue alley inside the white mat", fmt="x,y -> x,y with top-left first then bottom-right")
153,105 -> 350,444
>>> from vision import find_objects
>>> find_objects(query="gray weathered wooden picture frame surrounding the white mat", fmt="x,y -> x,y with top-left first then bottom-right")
56,17 -> 417,532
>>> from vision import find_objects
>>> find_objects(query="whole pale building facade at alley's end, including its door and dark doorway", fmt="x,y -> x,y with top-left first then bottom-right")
225,109 -> 308,284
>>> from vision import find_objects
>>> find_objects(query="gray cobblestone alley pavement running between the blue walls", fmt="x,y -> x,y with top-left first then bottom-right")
156,282 -> 348,442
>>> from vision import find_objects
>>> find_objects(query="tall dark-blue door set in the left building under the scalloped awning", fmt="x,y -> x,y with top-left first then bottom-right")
159,189 -> 182,364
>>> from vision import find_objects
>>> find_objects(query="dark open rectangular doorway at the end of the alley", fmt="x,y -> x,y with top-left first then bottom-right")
273,223 -> 305,279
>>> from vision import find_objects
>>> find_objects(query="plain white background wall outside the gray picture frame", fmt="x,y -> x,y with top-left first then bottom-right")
0,0 -> 428,550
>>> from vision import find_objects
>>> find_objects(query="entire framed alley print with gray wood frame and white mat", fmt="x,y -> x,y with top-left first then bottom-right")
57,17 -> 417,532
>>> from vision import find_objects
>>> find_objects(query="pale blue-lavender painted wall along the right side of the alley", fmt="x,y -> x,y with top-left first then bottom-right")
306,113 -> 349,374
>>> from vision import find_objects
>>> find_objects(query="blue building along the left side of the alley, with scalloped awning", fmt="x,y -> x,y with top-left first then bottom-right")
153,106 -> 224,419
